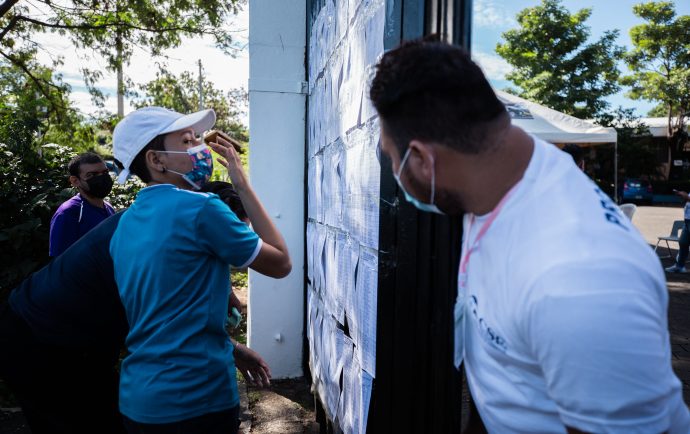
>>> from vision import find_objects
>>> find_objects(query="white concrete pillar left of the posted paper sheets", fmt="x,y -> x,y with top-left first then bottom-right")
248,0 -> 306,378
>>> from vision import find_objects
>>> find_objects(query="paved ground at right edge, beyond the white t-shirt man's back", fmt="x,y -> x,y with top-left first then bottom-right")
632,206 -> 690,404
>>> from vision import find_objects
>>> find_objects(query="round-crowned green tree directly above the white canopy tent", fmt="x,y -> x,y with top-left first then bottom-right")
496,0 -> 623,119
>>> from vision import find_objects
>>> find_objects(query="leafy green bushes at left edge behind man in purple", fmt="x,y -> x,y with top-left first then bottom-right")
0,57 -> 140,296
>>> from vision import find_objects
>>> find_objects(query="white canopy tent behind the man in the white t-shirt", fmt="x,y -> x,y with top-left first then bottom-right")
496,90 -> 618,202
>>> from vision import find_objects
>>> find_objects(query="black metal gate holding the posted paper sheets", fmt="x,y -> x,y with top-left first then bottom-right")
305,0 -> 472,433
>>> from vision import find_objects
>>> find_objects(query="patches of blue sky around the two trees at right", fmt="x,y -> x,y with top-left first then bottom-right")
472,0 -> 690,116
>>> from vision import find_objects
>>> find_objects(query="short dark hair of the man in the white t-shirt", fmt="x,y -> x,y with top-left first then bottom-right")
369,38 -> 508,154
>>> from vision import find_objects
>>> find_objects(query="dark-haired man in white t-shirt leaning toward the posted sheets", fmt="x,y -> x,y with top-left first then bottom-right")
370,41 -> 690,433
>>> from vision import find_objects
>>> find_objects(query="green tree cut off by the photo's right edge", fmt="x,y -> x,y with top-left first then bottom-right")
621,2 -> 690,177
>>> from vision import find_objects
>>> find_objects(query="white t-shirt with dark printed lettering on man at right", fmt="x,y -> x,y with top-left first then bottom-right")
456,139 -> 690,434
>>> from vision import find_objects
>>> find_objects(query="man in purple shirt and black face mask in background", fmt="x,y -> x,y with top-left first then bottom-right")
49,152 -> 115,257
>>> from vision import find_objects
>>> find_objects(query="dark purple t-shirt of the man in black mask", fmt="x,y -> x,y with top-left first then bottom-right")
48,193 -> 115,257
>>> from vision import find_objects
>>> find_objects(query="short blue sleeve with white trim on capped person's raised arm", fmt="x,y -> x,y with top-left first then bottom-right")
197,195 -> 261,267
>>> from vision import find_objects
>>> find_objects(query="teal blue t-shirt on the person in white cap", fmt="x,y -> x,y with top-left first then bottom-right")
110,184 -> 261,423
